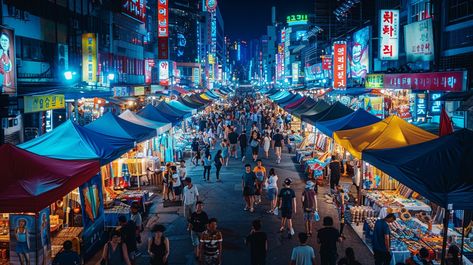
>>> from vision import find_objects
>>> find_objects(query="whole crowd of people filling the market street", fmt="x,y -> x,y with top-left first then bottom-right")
49,92 -> 460,265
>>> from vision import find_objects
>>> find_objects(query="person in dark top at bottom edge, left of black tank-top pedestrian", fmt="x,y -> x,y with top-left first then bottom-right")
100,230 -> 132,265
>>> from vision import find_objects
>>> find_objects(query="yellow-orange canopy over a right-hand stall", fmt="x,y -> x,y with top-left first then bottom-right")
333,116 -> 437,159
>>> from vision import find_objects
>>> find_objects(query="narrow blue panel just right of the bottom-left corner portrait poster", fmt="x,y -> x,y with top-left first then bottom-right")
38,207 -> 51,264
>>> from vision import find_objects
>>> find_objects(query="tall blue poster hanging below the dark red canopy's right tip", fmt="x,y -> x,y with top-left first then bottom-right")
79,174 -> 105,255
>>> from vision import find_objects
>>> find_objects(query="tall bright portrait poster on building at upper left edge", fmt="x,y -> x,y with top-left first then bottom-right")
0,27 -> 16,96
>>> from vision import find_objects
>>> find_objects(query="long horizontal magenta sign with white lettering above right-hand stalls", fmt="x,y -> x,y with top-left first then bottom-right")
384,71 -> 467,92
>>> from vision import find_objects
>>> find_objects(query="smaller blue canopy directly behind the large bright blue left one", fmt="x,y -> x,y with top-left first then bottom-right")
85,112 -> 156,142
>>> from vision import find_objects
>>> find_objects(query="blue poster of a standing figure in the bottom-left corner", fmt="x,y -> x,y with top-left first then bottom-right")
10,214 -> 37,264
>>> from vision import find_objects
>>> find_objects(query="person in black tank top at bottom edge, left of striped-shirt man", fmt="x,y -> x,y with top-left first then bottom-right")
148,225 -> 170,265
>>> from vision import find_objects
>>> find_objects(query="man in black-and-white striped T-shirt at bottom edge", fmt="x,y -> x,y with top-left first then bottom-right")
200,218 -> 223,265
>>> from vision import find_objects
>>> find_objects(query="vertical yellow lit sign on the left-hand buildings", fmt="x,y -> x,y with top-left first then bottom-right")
82,33 -> 97,83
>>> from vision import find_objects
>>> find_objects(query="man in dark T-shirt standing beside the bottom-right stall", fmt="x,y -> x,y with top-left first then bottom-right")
372,213 -> 396,265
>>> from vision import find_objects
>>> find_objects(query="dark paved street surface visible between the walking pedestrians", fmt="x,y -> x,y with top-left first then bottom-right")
97,139 -> 373,265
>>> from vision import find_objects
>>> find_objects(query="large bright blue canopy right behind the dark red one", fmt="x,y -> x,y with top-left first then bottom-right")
18,120 -> 135,165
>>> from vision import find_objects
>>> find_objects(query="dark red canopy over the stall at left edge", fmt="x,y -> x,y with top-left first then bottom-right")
0,143 -> 100,213
